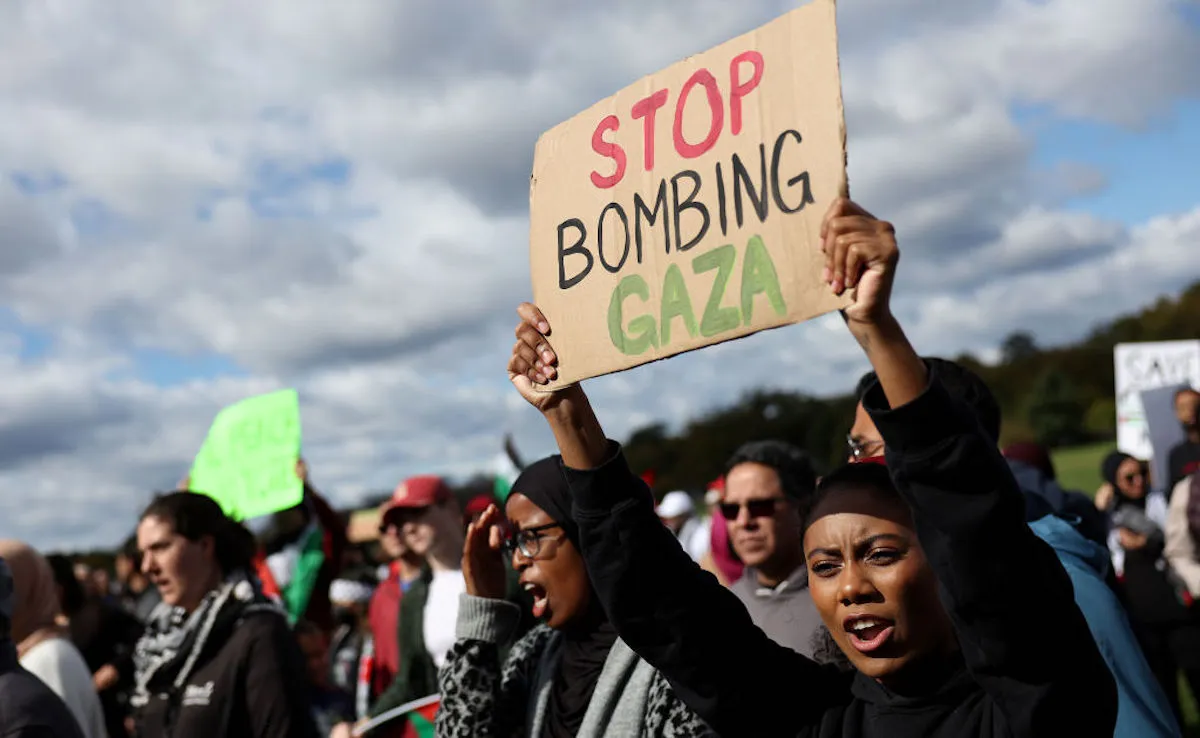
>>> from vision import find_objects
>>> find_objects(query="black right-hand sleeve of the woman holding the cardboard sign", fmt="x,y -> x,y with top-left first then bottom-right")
863,373 -> 1117,736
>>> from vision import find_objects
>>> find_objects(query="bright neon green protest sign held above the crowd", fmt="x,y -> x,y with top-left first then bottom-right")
188,390 -> 304,520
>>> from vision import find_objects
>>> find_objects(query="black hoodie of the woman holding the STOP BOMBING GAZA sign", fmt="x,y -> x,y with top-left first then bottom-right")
568,376 -> 1117,738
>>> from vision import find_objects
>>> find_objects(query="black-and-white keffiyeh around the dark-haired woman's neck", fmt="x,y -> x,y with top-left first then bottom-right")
130,571 -> 283,707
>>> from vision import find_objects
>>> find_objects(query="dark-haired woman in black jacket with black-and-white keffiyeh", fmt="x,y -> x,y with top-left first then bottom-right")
132,492 -> 317,738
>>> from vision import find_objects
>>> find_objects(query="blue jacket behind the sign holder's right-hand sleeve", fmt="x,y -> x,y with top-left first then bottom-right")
1030,515 -> 1180,738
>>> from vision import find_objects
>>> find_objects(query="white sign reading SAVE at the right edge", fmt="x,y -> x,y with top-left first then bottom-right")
1112,341 -> 1200,458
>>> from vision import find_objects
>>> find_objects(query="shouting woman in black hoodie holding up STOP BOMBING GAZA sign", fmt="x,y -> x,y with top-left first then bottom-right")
496,200 -> 1117,738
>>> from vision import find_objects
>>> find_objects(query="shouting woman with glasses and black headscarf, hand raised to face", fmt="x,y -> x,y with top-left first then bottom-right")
437,456 -> 713,738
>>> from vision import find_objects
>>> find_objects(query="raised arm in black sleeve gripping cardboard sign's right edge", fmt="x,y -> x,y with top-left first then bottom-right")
826,202 -> 1116,736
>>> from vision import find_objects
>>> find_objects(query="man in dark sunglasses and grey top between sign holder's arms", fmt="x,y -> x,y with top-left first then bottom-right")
720,440 -> 821,658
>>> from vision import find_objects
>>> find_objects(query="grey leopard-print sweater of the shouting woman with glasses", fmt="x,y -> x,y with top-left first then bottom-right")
437,594 -> 716,738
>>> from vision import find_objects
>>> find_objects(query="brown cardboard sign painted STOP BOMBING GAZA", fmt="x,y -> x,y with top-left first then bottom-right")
529,0 -> 848,389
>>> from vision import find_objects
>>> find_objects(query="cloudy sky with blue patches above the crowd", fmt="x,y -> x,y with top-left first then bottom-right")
0,0 -> 1200,548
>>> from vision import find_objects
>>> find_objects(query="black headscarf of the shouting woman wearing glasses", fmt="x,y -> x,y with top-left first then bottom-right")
512,456 -> 617,738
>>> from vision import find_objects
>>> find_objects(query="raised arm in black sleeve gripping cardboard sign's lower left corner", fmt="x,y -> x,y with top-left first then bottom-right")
509,305 -> 850,738
